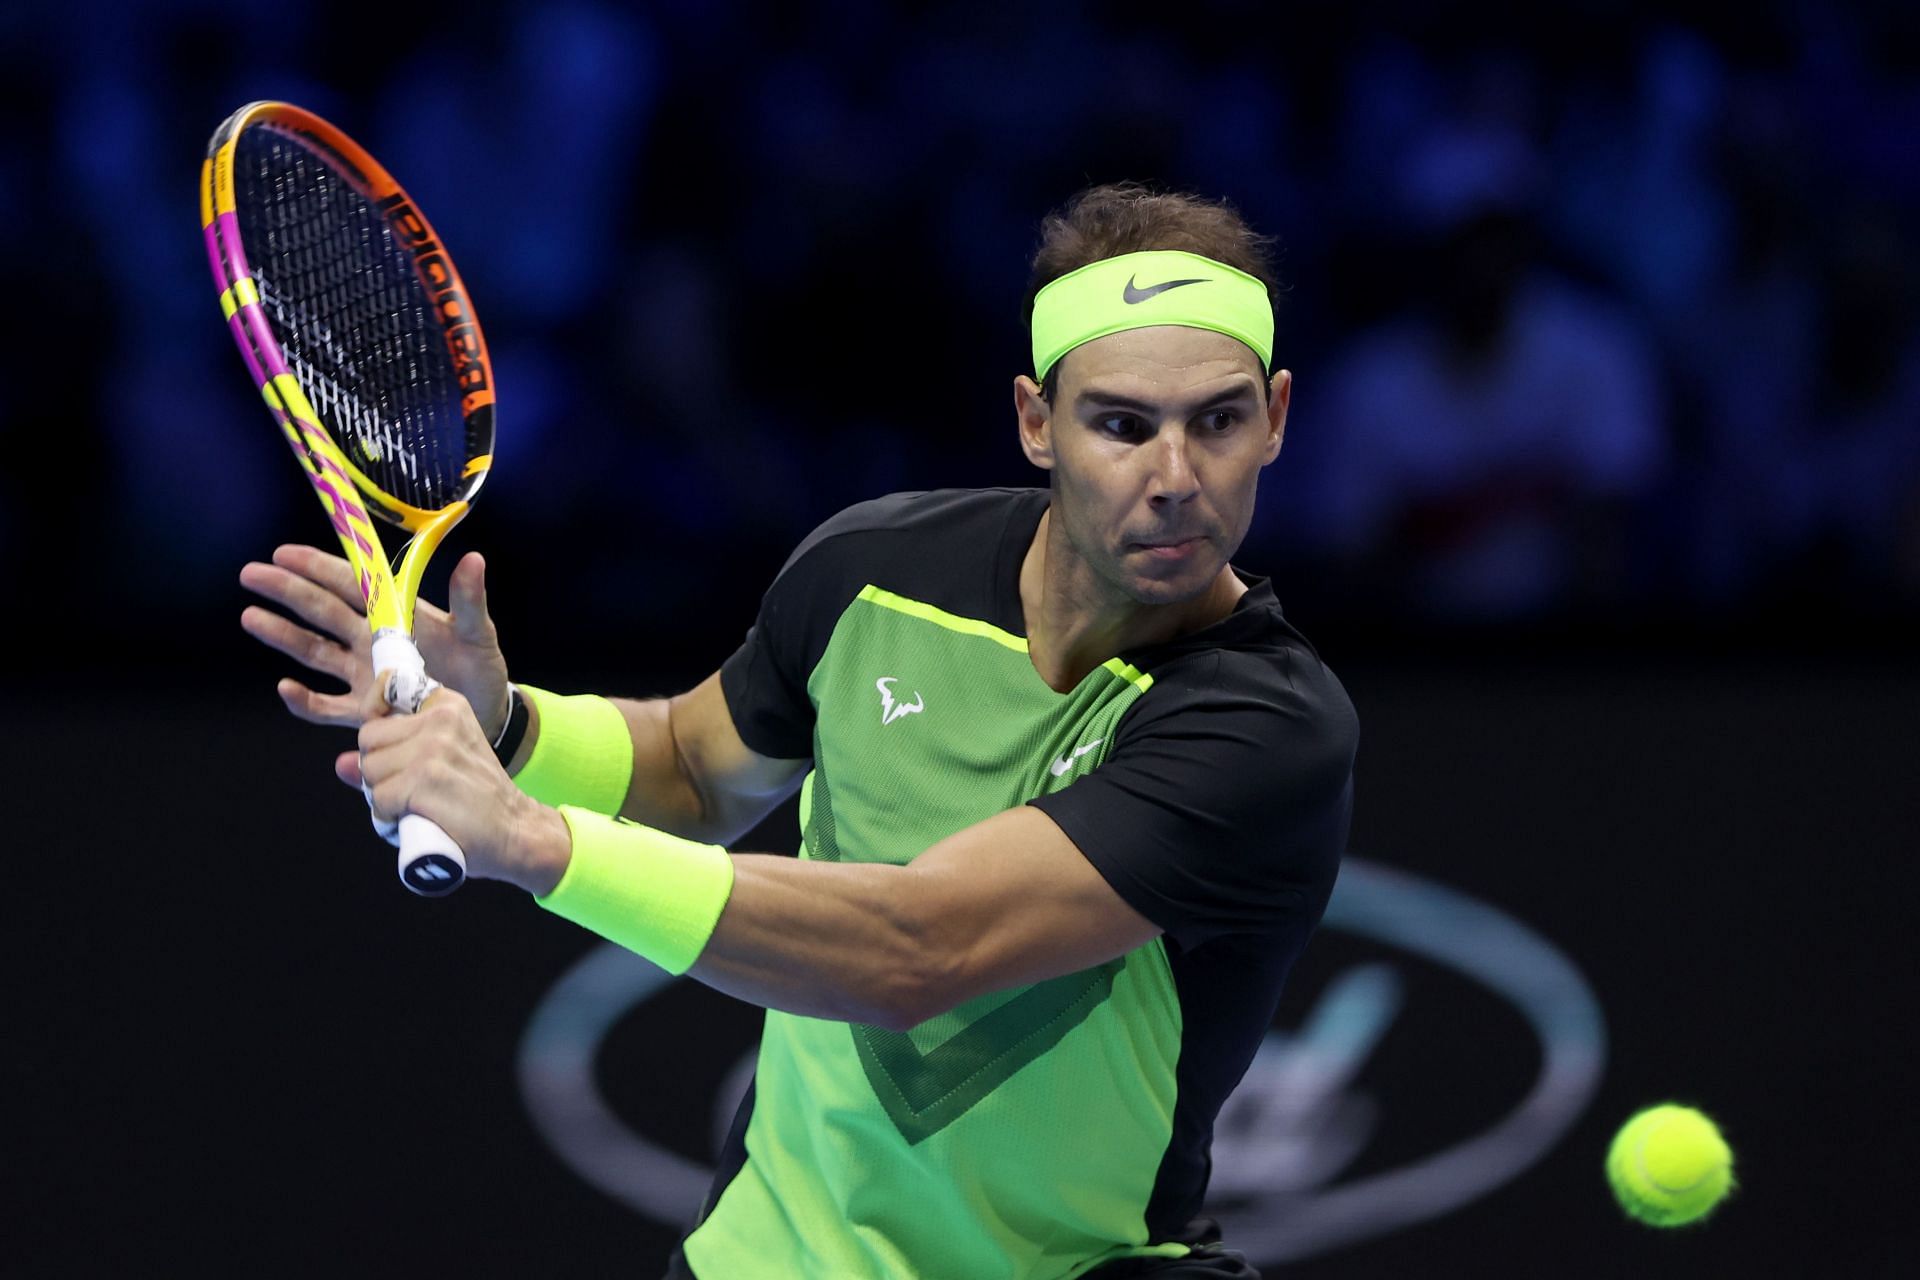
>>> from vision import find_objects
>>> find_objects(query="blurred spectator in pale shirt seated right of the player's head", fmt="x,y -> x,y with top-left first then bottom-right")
1302,123 -> 1667,622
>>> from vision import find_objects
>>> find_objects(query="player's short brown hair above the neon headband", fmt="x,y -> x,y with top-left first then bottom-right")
1020,182 -> 1281,399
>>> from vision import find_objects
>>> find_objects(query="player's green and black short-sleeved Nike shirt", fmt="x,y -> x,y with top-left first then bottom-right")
672,489 -> 1357,1280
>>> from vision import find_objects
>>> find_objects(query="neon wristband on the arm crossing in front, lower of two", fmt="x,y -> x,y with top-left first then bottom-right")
534,804 -> 733,973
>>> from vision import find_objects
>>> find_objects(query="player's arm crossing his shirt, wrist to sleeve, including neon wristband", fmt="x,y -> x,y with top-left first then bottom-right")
515,806 -> 1160,1029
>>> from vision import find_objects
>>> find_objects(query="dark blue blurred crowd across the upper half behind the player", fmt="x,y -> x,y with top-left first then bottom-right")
0,0 -> 1920,656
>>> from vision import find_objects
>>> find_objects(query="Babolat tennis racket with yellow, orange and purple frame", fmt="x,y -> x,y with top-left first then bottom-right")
200,102 -> 493,896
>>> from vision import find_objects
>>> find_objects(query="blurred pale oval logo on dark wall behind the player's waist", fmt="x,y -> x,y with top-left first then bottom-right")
520,858 -> 1607,1265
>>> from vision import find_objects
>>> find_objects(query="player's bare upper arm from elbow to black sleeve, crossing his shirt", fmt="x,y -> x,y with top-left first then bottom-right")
908,804 -> 1160,1007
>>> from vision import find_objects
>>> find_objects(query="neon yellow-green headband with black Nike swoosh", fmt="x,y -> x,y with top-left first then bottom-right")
1033,249 -> 1273,382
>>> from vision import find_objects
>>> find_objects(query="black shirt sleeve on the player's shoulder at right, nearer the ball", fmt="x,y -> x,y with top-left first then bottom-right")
1029,652 -> 1359,948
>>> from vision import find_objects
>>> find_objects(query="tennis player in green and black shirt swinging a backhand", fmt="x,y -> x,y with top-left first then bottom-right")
242,186 -> 1357,1280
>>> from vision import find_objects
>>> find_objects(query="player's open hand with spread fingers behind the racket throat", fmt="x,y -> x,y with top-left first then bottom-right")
240,547 -> 507,741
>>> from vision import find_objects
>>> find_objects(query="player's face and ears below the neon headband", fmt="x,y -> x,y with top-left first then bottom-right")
1016,326 -> 1292,604
